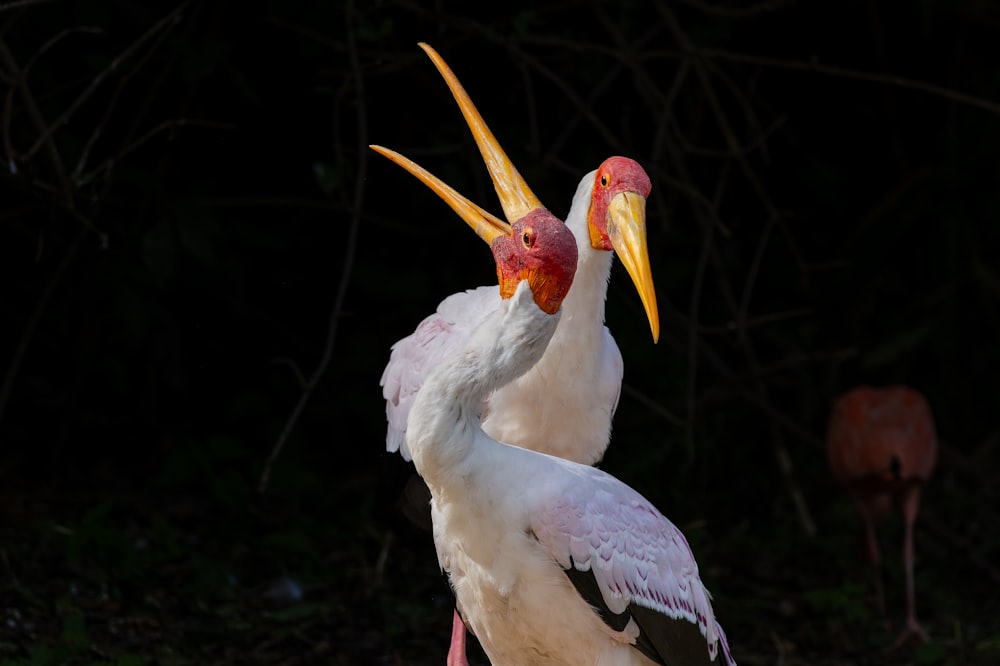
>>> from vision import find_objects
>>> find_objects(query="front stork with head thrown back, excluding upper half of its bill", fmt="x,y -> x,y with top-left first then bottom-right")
380,149 -> 734,666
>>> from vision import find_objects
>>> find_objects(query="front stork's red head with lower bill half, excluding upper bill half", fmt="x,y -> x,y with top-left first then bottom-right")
371,146 -> 577,314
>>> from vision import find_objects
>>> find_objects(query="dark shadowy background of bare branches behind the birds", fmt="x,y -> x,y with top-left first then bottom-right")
0,0 -> 1000,665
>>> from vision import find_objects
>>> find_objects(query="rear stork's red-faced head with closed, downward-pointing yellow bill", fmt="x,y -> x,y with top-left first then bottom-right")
587,156 -> 660,342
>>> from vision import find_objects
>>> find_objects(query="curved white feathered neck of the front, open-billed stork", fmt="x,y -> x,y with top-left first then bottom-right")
407,282 -> 560,491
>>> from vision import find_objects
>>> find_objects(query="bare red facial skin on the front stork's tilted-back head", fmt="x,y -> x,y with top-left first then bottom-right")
492,208 -> 577,314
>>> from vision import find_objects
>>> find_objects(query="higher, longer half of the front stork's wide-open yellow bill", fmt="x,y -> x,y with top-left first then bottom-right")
419,42 -> 542,222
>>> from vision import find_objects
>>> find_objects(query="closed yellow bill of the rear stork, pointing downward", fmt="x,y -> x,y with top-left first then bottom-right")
608,192 -> 660,343
